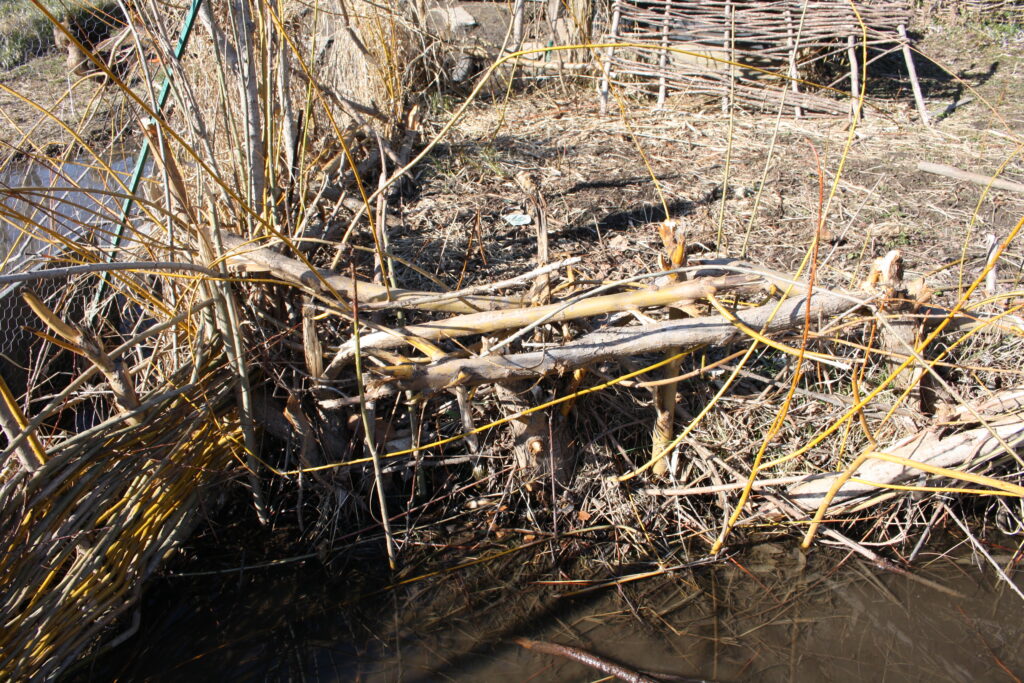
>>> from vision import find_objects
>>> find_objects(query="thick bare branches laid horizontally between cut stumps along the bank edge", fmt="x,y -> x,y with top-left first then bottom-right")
225,216 -> 1024,536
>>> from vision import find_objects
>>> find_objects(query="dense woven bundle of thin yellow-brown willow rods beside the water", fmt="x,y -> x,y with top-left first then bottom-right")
0,315 -> 245,680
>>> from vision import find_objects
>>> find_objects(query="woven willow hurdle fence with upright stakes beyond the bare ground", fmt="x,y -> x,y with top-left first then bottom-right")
600,0 -> 927,121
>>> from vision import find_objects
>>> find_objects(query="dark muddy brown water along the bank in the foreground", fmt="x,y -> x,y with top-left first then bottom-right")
75,540 -> 1024,682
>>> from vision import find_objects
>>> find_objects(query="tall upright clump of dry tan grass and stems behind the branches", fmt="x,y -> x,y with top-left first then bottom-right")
149,0 -> 444,227
